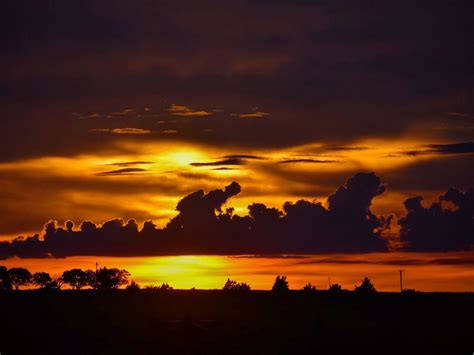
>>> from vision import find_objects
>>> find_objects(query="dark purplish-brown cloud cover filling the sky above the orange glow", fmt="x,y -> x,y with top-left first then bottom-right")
0,0 -> 474,160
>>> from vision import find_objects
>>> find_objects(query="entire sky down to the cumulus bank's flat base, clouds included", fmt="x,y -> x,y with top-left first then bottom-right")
0,0 -> 474,268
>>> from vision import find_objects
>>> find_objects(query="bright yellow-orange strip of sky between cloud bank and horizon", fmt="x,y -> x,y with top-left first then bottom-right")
2,252 -> 474,292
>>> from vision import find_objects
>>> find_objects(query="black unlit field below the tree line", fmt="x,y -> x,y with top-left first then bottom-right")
0,290 -> 474,355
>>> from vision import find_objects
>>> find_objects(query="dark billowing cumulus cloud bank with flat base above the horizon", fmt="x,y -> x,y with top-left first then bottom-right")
0,173 -> 468,262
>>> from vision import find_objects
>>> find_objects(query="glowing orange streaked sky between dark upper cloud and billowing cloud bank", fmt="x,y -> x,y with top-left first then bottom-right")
0,134 -> 466,239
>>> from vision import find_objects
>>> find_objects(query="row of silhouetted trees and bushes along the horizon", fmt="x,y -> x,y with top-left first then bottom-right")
0,266 -> 392,294
